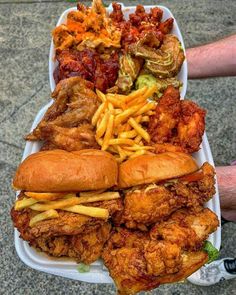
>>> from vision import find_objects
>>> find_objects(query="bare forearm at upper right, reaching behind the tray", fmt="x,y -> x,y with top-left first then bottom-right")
186,34 -> 236,79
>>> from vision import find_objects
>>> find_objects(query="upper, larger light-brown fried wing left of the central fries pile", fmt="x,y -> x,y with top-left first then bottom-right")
26,77 -> 99,140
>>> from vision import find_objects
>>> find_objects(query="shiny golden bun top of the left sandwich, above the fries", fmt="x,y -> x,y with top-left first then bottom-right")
13,149 -> 118,192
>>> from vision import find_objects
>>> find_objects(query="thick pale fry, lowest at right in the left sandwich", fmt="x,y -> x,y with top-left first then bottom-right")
63,205 -> 109,220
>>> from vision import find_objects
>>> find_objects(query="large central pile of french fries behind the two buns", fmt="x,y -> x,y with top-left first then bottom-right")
92,85 -> 156,162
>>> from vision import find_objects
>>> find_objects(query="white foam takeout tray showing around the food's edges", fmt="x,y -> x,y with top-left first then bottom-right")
15,4 -> 221,283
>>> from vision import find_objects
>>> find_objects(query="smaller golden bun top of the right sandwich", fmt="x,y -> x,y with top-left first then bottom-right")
118,152 -> 199,188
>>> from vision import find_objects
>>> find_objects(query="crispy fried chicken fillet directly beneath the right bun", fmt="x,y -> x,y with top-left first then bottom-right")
116,163 -> 215,230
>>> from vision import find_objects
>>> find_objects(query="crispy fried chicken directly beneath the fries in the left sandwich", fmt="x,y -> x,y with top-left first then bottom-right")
11,194 -> 122,242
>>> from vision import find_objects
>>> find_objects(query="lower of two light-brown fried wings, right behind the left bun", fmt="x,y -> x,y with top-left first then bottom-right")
37,124 -> 99,151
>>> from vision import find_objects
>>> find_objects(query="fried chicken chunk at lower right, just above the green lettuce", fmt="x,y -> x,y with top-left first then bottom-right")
150,208 -> 219,250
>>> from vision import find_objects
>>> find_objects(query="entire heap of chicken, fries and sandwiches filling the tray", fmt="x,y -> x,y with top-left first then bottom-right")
11,0 -> 219,294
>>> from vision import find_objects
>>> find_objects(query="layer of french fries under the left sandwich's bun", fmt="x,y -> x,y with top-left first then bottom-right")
15,191 -> 120,227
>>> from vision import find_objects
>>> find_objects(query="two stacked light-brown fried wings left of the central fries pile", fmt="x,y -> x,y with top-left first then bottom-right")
26,77 -> 99,151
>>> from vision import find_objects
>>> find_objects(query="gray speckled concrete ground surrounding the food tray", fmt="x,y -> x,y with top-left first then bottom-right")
0,0 -> 236,295
